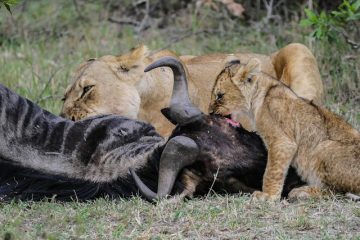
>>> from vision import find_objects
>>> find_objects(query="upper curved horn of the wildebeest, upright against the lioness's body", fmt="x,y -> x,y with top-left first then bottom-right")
144,57 -> 202,125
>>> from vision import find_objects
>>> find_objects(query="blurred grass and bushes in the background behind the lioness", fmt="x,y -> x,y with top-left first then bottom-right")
0,0 -> 360,124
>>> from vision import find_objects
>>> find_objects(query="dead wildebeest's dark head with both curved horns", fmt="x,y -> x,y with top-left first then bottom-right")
130,57 -> 304,200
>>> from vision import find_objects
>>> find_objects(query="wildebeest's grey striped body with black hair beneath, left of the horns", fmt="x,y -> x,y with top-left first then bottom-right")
0,84 -> 181,200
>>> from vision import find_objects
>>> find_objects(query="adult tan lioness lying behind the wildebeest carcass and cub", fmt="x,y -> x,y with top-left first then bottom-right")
61,43 -> 323,136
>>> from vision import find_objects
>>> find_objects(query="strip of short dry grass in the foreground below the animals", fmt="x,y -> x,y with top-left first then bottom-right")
0,195 -> 360,239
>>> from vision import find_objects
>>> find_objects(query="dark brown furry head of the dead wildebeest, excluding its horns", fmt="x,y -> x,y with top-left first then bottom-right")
162,115 -> 304,196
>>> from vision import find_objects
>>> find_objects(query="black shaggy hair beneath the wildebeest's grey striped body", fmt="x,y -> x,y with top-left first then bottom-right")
0,151 -> 169,201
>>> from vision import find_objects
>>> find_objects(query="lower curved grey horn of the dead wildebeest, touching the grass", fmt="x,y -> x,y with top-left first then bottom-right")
130,136 -> 199,200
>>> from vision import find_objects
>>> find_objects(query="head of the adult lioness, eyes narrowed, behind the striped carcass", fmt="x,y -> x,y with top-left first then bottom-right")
61,46 -> 148,121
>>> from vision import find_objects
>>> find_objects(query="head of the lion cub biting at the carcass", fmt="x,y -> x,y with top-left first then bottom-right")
209,58 -> 260,116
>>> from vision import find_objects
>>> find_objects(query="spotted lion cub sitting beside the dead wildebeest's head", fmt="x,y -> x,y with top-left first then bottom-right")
210,58 -> 360,200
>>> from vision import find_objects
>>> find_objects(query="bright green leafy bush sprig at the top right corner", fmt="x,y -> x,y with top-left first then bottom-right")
300,0 -> 360,41
